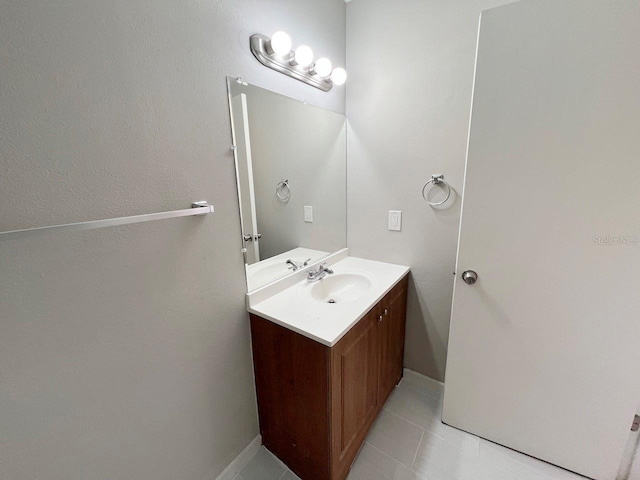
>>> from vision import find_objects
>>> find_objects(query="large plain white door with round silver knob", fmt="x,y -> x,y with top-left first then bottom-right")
443,0 -> 640,480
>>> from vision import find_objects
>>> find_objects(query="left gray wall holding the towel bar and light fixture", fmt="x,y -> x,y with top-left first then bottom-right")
0,0 -> 345,480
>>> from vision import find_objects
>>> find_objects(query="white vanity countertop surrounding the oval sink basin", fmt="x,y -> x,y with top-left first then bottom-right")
247,257 -> 409,347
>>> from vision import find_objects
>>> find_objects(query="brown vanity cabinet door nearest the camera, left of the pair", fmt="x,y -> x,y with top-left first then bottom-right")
331,308 -> 380,479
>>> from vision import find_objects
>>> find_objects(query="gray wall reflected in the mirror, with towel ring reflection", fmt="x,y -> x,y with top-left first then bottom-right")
247,87 -> 347,260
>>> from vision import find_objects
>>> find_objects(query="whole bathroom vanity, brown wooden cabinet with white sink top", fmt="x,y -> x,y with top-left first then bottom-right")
249,253 -> 409,480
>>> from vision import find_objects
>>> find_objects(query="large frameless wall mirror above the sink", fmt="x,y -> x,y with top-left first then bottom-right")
227,78 -> 347,291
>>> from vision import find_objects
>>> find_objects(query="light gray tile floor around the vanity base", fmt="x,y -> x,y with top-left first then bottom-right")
234,375 -> 585,480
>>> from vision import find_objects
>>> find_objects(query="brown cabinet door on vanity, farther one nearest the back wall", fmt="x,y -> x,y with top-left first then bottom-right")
378,278 -> 407,405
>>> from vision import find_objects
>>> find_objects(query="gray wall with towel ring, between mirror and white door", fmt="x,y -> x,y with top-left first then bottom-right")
347,0 -> 510,380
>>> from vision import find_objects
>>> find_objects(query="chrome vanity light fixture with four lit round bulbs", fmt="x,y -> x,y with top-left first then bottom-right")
250,31 -> 347,92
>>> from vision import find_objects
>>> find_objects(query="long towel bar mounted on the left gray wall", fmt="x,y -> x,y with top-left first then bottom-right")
0,202 -> 214,240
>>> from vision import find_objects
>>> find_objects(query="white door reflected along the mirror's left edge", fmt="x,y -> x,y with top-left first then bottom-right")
231,93 -> 260,265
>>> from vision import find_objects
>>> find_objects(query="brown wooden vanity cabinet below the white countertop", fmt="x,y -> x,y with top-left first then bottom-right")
251,276 -> 408,480
